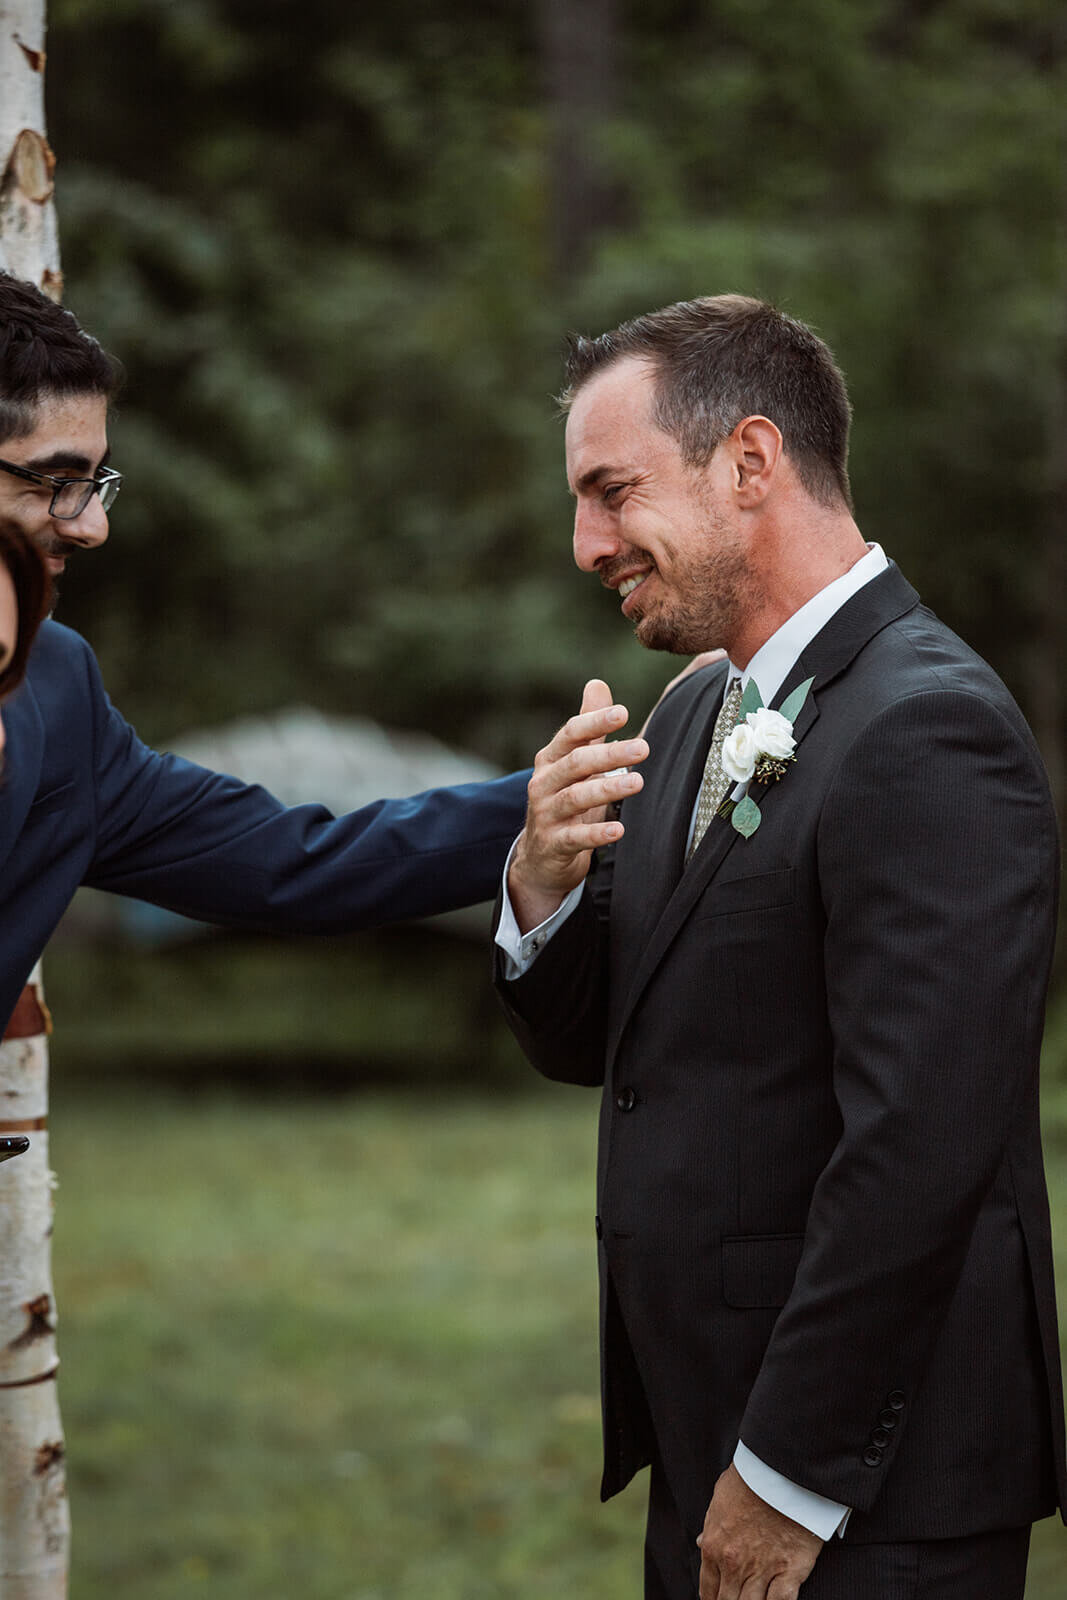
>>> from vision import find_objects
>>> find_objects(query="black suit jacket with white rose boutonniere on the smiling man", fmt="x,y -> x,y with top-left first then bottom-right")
501,568 -> 1065,1539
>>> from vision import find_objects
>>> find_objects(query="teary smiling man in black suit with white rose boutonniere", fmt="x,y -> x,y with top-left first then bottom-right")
498,296 -> 1067,1600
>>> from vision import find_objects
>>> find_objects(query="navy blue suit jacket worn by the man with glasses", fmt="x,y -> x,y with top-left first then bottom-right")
0,622 -> 530,1030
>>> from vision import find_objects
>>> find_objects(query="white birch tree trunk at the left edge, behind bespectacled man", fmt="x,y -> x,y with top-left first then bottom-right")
0,0 -> 70,1600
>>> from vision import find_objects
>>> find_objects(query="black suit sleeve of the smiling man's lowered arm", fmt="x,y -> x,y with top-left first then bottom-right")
741,691 -> 1057,1509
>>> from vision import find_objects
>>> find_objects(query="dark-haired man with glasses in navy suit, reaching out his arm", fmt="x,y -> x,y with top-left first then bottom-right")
0,274 -> 530,1027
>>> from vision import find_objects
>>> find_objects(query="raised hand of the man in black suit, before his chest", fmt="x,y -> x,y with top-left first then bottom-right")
507,678 -> 648,933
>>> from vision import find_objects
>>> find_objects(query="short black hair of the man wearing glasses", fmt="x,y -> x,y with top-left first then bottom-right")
0,272 -> 122,443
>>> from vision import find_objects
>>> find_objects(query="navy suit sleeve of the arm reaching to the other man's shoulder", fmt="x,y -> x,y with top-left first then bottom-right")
75,633 -> 530,933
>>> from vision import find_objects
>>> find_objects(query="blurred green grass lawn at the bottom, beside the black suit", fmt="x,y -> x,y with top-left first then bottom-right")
53,1086 -> 1067,1600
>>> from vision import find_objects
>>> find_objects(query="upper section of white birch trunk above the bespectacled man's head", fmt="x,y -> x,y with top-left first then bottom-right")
0,0 -> 62,299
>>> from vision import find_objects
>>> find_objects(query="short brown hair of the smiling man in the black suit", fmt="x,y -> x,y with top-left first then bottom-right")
560,294 -> 853,510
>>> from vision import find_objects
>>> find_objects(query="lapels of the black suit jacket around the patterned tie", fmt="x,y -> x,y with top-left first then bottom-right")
608,562 -> 918,1062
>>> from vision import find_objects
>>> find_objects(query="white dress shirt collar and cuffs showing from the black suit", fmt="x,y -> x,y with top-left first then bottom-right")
496,544 -> 889,1539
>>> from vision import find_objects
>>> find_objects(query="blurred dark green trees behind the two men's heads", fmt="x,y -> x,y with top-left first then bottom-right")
50,0 -> 1067,780
